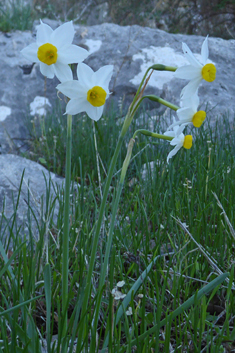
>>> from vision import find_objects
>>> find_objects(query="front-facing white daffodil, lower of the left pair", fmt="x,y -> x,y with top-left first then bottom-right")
56,63 -> 113,121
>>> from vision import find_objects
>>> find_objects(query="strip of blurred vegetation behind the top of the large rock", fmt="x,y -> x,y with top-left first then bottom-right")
0,0 -> 235,39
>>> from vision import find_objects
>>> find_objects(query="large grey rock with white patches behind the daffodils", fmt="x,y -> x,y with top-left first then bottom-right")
0,20 -> 235,153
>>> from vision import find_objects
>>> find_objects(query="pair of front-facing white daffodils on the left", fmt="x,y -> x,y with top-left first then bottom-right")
21,21 -> 113,121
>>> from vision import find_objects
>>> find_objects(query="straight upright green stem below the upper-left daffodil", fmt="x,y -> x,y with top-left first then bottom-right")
62,115 -> 72,337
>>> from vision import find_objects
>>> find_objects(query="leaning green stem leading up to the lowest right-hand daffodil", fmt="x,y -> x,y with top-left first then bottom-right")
90,138 -> 135,352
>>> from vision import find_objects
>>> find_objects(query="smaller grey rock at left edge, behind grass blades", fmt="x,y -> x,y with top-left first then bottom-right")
0,154 -> 64,245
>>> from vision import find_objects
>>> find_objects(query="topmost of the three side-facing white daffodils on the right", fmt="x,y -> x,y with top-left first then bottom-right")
175,36 -> 216,98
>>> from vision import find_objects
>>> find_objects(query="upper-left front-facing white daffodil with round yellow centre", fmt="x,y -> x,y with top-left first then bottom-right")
21,21 -> 89,82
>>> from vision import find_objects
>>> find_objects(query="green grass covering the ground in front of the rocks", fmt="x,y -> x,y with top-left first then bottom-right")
0,106 -> 235,352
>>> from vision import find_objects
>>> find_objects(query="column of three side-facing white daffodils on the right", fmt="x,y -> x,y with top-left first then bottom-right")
164,36 -> 216,162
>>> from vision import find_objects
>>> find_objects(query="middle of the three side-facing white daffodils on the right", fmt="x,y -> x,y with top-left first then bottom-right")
168,94 -> 206,129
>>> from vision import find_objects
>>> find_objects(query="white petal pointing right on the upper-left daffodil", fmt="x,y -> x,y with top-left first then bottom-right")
58,44 -> 89,64
